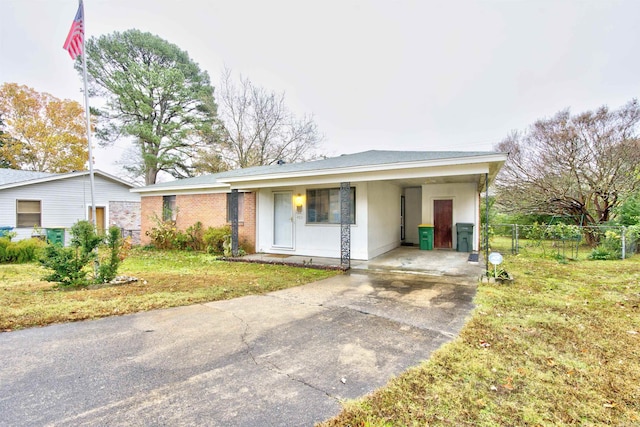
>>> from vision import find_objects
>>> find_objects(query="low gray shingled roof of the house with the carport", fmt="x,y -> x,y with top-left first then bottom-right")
132,150 -> 506,193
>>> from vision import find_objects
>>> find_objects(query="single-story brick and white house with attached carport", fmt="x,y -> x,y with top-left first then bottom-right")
132,150 -> 507,260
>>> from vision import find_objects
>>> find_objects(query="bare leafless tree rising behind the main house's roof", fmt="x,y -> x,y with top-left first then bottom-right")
198,70 -> 322,172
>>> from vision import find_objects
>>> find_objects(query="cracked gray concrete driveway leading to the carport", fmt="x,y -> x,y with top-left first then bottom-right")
0,272 -> 475,426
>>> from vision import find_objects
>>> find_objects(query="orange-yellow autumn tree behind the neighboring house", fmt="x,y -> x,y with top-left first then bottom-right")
0,83 -> 88,173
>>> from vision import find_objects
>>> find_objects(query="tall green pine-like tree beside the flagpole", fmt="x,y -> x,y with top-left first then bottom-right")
81,30 -> 216,185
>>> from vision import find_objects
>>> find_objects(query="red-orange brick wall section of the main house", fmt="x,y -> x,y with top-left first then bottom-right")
141,193 -> 256,252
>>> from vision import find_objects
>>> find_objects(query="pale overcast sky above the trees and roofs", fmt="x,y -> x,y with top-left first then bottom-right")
0,0 -> 640,176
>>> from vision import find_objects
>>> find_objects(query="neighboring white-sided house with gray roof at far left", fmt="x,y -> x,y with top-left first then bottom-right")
0,169 -> 140,246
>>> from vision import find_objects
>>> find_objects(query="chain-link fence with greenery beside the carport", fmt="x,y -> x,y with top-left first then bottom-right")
481,224 -> 640,259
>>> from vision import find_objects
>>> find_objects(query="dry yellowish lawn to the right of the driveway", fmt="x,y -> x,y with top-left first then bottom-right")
323,255 -> 640,426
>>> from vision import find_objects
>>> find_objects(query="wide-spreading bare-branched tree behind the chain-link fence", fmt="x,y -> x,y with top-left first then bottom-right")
497,100 -> 640,234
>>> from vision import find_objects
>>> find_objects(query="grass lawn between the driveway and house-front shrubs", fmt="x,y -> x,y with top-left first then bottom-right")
0,250 -> 337,331
